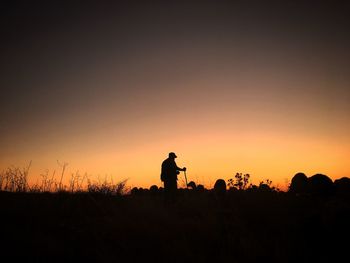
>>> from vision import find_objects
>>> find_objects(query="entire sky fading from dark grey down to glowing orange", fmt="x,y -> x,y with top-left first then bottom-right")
0,1 -> 350,188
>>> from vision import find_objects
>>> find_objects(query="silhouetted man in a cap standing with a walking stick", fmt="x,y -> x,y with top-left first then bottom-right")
160,152 -> 186,200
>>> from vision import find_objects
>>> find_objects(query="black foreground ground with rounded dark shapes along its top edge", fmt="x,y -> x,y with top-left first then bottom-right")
0,174 -> 350,262
